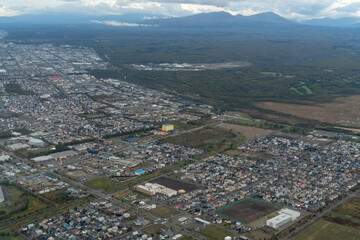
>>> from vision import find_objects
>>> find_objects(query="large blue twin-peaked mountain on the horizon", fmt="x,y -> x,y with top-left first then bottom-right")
144,12 -> 296,28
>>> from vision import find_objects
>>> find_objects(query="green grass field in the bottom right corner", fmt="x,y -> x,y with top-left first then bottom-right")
291,220 -> 360,240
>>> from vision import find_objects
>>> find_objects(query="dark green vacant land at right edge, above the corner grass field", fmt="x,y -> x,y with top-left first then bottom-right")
325,197 -> 360,230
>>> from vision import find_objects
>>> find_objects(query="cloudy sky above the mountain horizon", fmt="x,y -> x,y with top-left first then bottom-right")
0,0 -> 360,20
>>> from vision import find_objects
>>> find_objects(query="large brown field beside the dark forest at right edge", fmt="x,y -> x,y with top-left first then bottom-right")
257,95 -> 360,127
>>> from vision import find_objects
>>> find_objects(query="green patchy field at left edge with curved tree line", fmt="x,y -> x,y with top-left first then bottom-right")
0,186 -> 48,225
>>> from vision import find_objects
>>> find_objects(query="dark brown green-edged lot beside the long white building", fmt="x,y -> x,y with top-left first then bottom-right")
216,198 -> 281,224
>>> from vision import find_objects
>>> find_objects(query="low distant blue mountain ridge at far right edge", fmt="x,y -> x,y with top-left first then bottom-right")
301,17 -> 360,28
